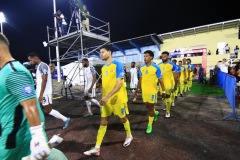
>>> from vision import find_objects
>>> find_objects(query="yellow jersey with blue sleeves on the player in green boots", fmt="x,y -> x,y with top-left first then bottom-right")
139,63 -> 162,95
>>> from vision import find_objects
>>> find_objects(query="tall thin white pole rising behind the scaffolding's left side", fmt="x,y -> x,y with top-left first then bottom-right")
53,0 -> 61,82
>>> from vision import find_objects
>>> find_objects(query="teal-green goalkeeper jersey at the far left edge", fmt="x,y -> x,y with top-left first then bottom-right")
0,61 -> 44,149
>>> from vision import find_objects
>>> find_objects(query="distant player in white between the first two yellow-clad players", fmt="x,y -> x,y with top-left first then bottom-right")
130,62 -> 138,93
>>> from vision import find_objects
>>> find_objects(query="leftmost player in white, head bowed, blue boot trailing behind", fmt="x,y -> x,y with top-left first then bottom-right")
28,53 -> 70,129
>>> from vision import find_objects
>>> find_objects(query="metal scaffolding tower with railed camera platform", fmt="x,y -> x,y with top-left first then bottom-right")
47,10 -> 110,98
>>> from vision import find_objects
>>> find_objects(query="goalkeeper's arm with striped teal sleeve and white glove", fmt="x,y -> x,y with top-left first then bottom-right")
6,71 -> 50,159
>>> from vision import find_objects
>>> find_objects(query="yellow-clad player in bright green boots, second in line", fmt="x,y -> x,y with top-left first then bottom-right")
134,50 -> 165,134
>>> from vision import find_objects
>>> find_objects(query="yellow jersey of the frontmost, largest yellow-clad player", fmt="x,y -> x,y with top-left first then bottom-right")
102,60 -> 128,105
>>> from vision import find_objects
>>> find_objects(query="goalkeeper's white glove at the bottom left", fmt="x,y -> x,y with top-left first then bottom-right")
30,125 -> 51,160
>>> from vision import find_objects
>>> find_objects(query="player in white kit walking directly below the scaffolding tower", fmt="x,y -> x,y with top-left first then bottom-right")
82,58 -> 101,117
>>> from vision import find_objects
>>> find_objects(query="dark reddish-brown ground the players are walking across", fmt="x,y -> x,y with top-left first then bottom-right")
46,82 -> 240,160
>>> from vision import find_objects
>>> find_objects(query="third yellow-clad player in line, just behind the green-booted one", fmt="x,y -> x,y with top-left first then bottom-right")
158,51 -> 177,118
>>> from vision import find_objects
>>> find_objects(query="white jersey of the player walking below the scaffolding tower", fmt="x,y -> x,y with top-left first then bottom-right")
84,65 -> 96,89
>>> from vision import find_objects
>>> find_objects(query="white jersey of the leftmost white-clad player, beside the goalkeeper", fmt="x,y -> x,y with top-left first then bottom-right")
36,62 -> 52,97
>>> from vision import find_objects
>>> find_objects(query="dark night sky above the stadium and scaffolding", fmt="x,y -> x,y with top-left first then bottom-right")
0,0 -> 240,63
